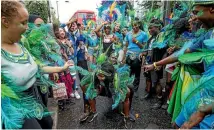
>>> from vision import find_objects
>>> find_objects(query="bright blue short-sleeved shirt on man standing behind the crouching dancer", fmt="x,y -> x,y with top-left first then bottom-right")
126,31 -> 148,53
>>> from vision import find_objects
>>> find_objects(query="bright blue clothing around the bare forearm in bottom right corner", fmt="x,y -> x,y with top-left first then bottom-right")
175,84 -> 214,129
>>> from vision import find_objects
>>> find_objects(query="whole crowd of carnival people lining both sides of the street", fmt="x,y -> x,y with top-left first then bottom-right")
1,0 -> 214,129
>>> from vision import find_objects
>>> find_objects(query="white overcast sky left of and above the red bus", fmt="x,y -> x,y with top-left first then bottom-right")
50,0 -> 101,22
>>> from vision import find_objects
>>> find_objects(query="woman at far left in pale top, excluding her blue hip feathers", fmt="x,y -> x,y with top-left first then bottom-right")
1,1 -> 72,129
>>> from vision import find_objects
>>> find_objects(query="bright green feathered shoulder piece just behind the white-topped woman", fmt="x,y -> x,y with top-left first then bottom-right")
21,24 -> 62,65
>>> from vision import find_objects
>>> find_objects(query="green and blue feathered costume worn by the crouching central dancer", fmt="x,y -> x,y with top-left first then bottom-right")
81,61 -> 134,109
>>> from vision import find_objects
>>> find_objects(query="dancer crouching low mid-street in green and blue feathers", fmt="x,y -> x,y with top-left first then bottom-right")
80,61 -> 134,128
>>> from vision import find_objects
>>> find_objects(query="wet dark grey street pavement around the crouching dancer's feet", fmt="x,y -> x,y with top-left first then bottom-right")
57,72 -> 171,129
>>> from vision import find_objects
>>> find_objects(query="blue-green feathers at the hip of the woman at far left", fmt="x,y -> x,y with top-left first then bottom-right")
1,74 -> 50,129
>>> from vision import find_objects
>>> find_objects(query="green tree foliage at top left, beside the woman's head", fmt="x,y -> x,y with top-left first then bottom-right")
24,0 -> 49,23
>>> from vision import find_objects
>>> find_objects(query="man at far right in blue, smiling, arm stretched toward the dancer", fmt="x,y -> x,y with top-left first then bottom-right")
144,1 -> 214,128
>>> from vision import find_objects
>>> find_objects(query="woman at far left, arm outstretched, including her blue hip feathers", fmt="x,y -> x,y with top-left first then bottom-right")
1,1 -> 73,129
